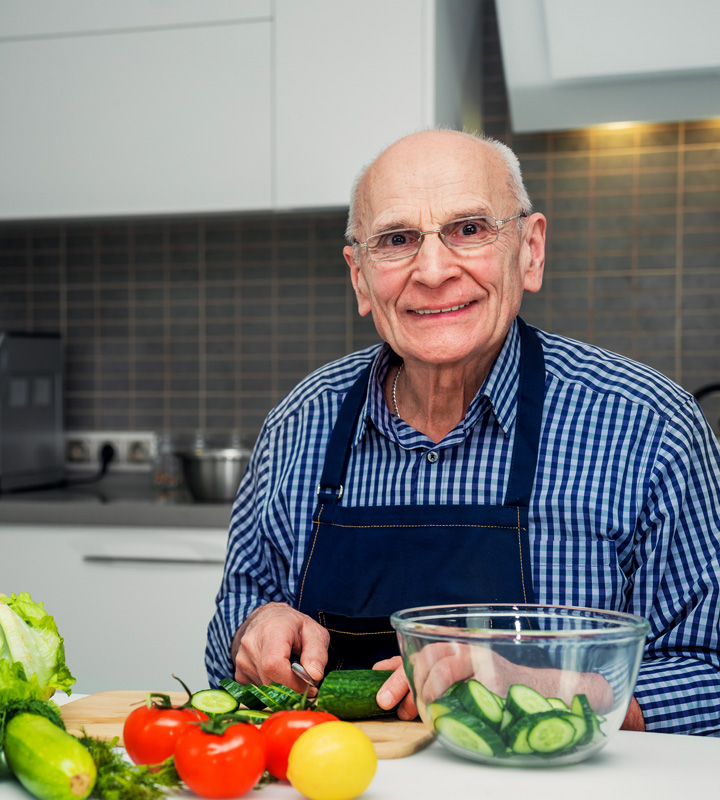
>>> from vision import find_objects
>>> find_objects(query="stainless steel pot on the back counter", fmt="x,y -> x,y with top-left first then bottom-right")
177,448 -> 250,503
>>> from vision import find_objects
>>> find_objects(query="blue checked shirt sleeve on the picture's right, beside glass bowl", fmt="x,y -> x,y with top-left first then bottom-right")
628,399 -> 720,735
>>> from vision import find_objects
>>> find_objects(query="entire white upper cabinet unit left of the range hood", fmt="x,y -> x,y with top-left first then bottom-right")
0,0 -> 480,220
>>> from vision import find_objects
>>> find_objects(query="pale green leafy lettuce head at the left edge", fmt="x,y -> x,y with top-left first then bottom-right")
0,592 -> 75,700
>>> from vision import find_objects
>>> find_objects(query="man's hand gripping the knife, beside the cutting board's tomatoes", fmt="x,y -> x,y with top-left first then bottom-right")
231,603 -> 330,692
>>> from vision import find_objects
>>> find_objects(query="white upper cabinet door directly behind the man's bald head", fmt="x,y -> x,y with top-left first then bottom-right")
275,0 -> 435,208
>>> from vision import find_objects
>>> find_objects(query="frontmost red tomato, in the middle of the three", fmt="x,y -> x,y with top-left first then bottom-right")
175,722 -> 265,797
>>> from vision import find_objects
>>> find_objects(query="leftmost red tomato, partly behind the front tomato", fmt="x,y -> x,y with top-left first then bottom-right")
123,705 -> 207,764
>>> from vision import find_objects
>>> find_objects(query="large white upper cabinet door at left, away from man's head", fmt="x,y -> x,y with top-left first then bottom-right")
0,20 -> 272,219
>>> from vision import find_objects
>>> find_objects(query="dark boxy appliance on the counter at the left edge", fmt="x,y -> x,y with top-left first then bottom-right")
0,331 -> 65,493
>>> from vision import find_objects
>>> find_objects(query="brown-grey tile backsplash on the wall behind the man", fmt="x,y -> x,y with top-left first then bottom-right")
0,3 -> 720,442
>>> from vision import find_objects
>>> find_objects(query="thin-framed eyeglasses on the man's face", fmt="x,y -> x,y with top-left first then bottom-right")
355,211 -> 527,261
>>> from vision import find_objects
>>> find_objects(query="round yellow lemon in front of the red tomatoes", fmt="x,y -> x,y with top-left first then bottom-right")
288,720 -> 377,800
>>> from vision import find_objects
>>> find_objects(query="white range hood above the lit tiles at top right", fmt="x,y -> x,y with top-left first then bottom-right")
496,0 -> 720,133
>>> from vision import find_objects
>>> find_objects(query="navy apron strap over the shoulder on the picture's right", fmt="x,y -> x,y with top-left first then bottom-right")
505,317 -> 545,508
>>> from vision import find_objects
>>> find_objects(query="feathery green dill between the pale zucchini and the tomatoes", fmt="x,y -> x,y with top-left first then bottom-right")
78,731 -> 183,800
